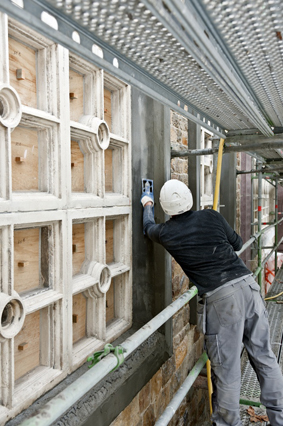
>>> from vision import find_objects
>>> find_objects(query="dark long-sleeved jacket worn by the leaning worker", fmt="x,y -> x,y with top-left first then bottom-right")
143,206 -> 251,296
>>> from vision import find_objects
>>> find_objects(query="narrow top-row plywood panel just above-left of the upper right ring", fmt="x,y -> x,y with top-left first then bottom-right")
69,69 -> 84,121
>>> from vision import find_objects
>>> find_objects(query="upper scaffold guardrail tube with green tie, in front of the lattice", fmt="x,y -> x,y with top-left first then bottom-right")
21,286 -> 198,426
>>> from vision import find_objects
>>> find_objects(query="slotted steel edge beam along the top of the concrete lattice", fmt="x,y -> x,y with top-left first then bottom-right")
0,0 -> 226,138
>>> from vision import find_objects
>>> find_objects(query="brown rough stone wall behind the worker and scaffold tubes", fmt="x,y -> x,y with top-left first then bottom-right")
111,112 -> 209,426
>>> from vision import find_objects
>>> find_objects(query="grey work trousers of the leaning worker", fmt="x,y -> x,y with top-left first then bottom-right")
205,277 -> 283,426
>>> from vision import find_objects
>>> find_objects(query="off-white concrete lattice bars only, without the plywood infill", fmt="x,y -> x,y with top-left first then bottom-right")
0,14 -> 132,424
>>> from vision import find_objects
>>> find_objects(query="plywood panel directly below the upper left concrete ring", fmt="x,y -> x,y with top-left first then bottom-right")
11,127 -> 38,191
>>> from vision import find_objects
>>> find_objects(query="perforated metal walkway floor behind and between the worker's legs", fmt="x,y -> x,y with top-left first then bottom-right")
241,269 -> 283,426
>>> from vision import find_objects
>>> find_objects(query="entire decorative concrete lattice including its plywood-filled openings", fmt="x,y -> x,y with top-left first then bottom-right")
0,14 -> 132,424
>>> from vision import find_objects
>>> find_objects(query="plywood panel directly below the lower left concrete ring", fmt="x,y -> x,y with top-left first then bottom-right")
14,311 -> 40,380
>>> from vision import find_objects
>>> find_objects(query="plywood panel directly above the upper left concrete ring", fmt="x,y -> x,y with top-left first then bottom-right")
9,37 -> 37,108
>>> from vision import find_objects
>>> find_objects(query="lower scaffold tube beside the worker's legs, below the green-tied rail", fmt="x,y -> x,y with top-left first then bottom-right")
155,352 -> 208,426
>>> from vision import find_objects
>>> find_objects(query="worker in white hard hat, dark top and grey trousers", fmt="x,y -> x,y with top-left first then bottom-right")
141,179 -> 283,426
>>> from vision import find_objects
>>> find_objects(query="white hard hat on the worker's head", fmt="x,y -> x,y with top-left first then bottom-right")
159,179 -> 193,216
